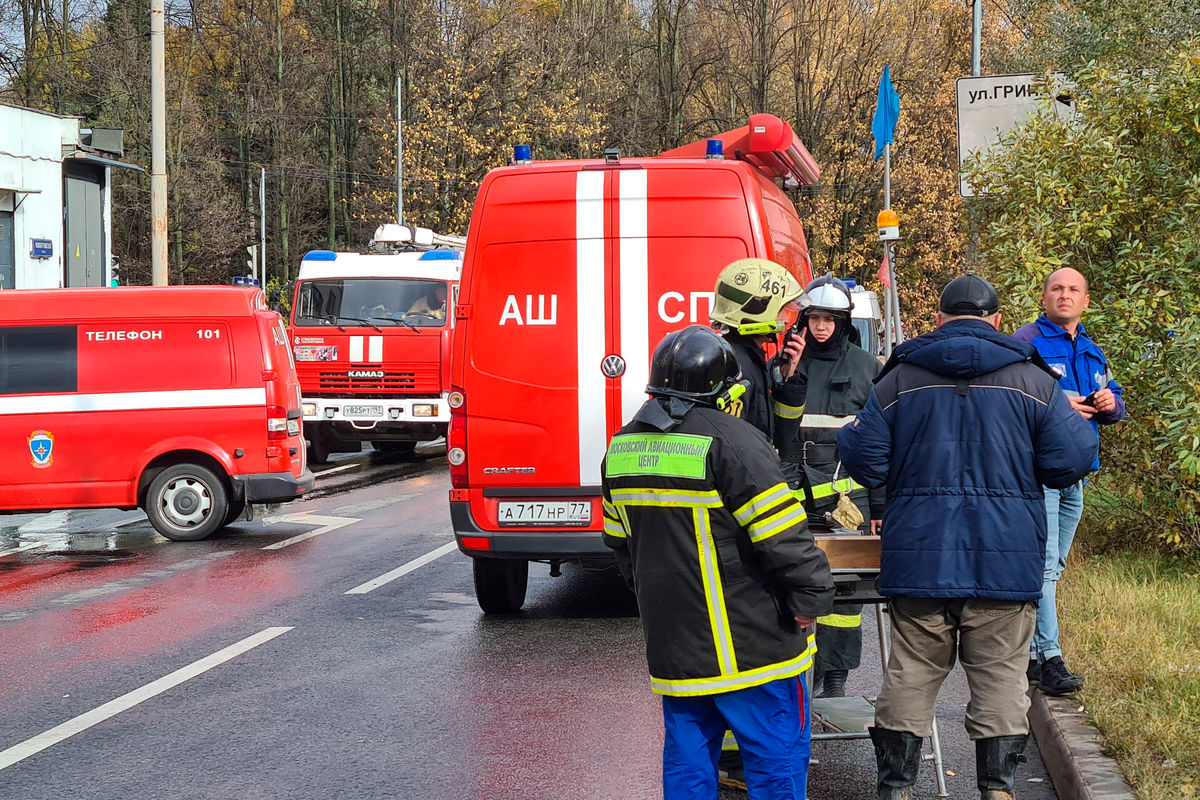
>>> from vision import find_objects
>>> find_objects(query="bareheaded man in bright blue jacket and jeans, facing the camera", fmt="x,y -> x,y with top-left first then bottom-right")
1013,266 -> 1124,696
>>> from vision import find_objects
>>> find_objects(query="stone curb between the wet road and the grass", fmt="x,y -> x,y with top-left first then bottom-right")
1028,690 -> 1134,800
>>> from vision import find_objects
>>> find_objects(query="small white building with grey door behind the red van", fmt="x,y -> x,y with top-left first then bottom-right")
0,103 -> 144,289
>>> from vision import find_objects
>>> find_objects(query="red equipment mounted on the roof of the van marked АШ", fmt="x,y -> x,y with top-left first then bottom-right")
659,114 -> 821,186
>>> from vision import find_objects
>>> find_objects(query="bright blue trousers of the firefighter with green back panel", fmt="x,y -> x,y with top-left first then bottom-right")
662,678 -> 811,800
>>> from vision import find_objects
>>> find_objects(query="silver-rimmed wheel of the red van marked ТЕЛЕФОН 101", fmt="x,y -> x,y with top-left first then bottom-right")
145,464 -> 229,542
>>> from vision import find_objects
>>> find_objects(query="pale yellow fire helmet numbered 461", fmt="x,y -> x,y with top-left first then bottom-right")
709,258 -> 804,336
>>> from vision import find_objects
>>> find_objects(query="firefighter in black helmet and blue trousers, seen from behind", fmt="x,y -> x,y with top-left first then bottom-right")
601,325 -> 833,800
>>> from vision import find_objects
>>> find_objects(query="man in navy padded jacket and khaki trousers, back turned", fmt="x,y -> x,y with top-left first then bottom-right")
838,275 -> 1097,800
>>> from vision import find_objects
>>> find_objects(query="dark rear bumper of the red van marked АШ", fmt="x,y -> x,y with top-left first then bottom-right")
450,500 -> 614,564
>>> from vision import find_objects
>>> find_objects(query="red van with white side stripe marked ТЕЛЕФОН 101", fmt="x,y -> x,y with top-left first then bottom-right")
0,287 -> 313,541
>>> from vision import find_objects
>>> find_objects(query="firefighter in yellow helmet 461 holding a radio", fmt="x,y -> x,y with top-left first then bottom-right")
709,258 -> 804,445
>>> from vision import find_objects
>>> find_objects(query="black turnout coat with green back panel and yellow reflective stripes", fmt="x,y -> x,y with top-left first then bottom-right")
601,398 -> 833,697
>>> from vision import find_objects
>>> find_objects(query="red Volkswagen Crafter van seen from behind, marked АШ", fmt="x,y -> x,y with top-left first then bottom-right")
448,114 -> 820,613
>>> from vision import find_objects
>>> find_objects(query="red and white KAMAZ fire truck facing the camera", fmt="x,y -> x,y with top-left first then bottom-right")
290,224 -> 466,464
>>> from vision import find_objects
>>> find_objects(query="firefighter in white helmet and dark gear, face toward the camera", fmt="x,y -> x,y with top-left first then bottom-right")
780,273 -> 886,697
